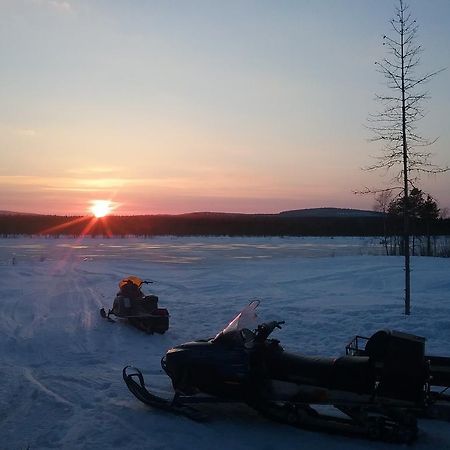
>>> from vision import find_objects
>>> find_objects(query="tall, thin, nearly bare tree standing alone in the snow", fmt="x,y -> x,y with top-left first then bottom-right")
368,0 -> 448,315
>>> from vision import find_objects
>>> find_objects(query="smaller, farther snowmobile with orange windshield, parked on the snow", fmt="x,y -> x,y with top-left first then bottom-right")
100,276 -> 169,334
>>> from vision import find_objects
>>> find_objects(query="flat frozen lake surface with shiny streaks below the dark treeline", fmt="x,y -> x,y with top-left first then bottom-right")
0,237 -> 384,263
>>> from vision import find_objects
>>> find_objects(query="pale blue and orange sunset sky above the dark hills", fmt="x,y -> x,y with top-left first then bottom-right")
0,0 -> 450,214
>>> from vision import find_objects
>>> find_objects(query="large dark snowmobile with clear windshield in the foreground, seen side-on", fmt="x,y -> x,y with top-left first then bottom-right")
123,301 -> 450,443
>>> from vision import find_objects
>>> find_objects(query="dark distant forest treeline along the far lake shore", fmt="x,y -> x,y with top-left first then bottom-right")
0,214 -> 450,237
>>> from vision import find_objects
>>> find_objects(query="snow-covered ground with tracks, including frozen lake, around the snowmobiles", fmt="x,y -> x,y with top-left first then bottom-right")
0,237 -> 450,450
